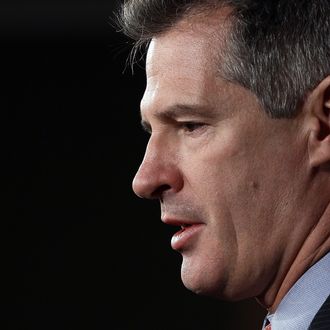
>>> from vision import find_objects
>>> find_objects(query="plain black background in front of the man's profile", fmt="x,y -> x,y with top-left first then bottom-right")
0,0 -> 264,330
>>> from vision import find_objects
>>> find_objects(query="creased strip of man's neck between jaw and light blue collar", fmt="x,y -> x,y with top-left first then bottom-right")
257,204 -> 330,313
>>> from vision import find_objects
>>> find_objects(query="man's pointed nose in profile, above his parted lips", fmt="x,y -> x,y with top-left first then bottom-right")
132,137 -> 183,199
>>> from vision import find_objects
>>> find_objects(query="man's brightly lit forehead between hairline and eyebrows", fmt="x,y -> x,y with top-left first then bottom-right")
141,12 -> 232,116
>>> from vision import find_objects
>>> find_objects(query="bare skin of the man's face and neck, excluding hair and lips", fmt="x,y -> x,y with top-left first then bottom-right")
133,10 -> 330,311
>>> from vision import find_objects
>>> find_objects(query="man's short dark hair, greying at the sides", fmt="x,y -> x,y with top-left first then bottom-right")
120,0 -> 330,118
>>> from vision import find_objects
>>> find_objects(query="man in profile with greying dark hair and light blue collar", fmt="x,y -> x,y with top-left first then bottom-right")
116,0 -> 330,330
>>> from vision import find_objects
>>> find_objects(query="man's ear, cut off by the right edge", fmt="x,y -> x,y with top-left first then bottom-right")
305,76 -> 330,168
